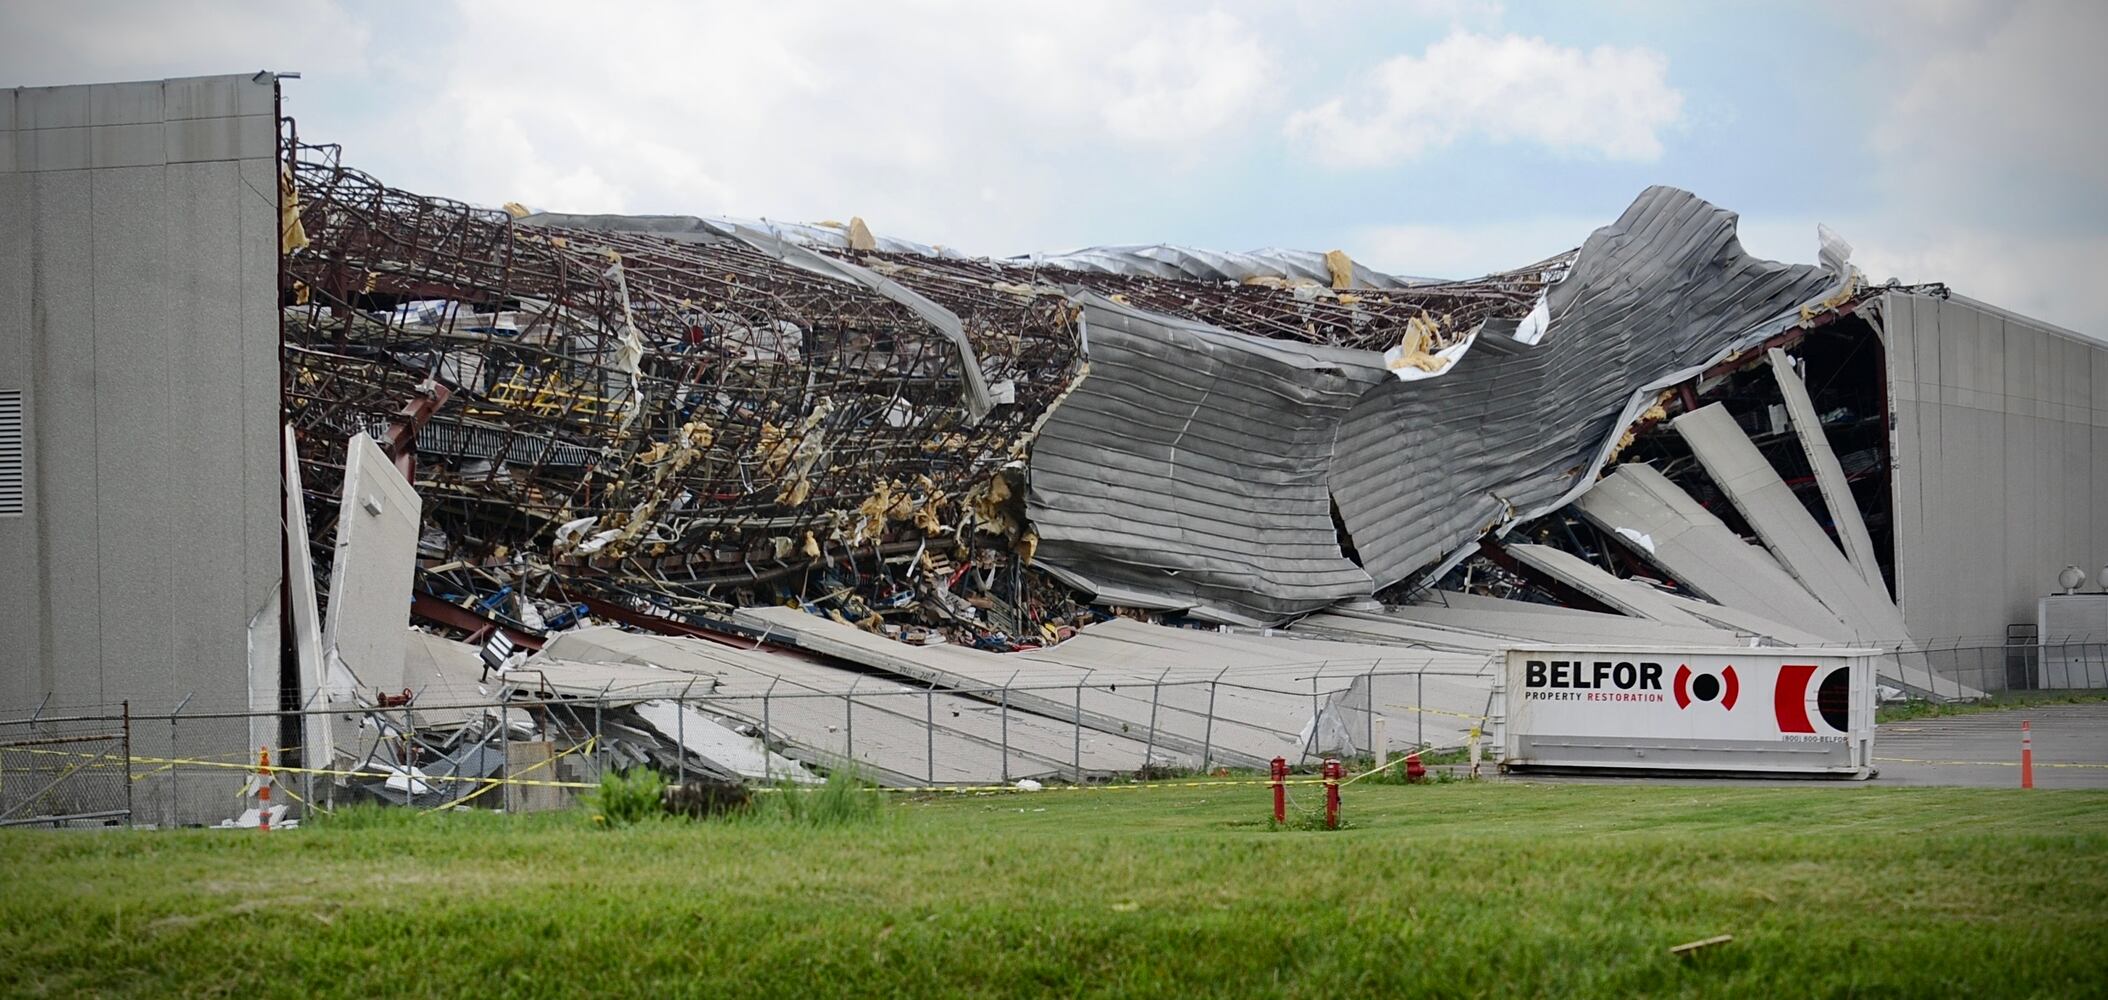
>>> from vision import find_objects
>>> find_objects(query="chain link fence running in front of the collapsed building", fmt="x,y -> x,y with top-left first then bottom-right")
0,641 -> 2108,825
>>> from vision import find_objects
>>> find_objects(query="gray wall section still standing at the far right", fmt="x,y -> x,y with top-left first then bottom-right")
1878,293 -> 2108,641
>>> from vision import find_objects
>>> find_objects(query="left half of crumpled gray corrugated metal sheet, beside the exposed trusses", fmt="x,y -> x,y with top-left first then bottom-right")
1027,293 -> 1389,622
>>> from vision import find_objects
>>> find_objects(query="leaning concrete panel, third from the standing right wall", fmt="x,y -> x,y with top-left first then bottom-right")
1575,462 -> 1855,641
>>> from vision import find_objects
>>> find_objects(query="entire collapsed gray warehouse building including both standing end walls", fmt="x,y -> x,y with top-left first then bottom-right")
0,74 -> 2108,816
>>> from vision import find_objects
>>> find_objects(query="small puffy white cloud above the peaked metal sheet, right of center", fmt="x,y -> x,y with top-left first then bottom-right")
1288,30 -> 1684,167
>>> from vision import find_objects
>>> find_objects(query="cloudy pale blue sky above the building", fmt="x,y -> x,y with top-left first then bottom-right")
0,0 -> 2108,335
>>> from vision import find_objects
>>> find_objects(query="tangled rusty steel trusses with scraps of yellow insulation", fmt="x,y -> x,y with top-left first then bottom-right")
282,130 -> 1570,650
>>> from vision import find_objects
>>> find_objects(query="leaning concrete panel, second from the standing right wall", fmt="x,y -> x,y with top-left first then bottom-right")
1672,403 -> 1910,646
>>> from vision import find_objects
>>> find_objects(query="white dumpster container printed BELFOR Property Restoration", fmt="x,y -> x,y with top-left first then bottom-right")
1495,648 -> 1876,778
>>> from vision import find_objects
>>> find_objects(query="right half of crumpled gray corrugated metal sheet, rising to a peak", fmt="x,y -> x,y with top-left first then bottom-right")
1332,188 -> 1840,586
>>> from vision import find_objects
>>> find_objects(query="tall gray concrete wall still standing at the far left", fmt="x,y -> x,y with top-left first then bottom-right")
0,76 -> 280,821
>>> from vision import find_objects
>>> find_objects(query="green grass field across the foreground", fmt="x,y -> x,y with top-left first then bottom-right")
0,783 -> 2108,998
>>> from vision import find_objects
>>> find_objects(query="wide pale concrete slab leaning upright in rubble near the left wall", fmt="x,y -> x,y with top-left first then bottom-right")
323,432 -> 422,700
